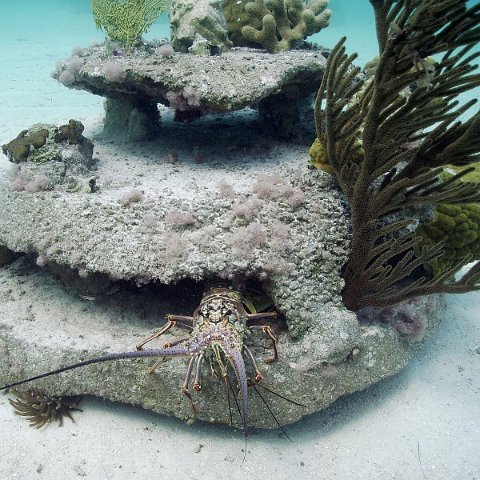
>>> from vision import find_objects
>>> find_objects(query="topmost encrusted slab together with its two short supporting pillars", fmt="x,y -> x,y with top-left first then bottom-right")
54,44 -> 326,141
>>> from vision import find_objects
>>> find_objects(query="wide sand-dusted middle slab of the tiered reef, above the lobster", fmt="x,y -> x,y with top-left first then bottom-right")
0,119 -> 348,338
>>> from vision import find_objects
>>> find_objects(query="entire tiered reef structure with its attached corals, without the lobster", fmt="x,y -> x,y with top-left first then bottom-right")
0,0 -> 480,427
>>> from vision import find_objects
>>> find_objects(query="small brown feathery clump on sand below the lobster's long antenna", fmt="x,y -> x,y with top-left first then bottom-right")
9,388 -> 82,428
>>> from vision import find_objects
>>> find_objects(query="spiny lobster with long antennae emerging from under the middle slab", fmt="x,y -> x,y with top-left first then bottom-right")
0,285 -> 278,436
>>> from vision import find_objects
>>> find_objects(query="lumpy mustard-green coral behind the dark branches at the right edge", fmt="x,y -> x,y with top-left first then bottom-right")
416,204 -> 480,275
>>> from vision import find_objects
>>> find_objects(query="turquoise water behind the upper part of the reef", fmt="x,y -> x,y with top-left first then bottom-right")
0,0 -> 478,141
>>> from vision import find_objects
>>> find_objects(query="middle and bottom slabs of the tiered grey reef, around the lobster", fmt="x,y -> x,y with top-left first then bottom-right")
0,118 -> 441,427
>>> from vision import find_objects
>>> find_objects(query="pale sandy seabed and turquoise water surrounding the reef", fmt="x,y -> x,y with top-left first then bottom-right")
0,0 -> 480,480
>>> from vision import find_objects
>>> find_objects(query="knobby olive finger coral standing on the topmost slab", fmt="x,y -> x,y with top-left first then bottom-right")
224,0 -> 331,53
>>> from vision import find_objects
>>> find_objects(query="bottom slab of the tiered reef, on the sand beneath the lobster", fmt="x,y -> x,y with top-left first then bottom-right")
0,260 -> 443,428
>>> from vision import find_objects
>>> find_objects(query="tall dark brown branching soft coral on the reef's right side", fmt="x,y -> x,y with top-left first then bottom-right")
315,0 -> 480,310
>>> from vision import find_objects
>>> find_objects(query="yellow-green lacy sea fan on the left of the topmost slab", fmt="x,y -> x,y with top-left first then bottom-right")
92,0 -> 172,49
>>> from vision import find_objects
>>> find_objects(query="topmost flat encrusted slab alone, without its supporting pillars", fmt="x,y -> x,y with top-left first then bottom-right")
54,45 -> 326,112
